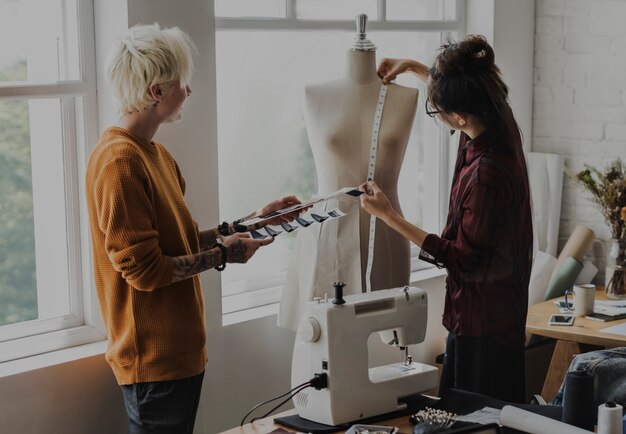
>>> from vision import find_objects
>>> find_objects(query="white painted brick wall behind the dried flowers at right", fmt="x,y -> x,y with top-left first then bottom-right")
532,0 -> 626,283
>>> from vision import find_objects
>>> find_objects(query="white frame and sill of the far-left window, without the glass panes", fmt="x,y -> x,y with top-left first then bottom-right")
0,0 -> 106,364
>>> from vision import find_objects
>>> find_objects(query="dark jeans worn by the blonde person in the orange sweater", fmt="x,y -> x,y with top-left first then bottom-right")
121,372 -> 204,434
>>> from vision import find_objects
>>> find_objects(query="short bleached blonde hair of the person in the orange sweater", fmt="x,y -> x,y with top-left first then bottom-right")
106,23 -> 196,113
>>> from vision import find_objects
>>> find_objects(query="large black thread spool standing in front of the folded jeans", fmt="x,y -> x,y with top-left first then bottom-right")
561,369 -> 596,431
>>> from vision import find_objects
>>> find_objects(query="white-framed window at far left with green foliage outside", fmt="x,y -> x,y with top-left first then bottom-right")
0,0 -> 103,362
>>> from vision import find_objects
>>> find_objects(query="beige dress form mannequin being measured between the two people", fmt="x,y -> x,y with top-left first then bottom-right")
278,16 -> 418,330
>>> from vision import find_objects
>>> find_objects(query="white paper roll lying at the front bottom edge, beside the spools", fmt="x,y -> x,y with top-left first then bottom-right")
500,405 -> 593,434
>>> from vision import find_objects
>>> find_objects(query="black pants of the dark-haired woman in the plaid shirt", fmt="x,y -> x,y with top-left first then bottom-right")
439,333 -> 525,403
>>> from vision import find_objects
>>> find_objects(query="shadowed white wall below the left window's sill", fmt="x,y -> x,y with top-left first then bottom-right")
0,355 -> 127,434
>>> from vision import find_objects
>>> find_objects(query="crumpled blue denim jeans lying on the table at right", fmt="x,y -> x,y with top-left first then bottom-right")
550,347 -> 626,407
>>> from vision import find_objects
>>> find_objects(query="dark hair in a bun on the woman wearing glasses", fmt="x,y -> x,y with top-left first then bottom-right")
427,35 -> 520,154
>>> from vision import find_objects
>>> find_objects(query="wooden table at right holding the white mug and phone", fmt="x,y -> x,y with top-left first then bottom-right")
526,287 -> 626,400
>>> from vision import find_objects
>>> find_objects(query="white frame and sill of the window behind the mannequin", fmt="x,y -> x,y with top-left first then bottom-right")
214,0 -> 466,326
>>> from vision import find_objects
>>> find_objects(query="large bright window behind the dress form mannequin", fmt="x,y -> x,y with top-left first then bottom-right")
215,0 -> 464,324
